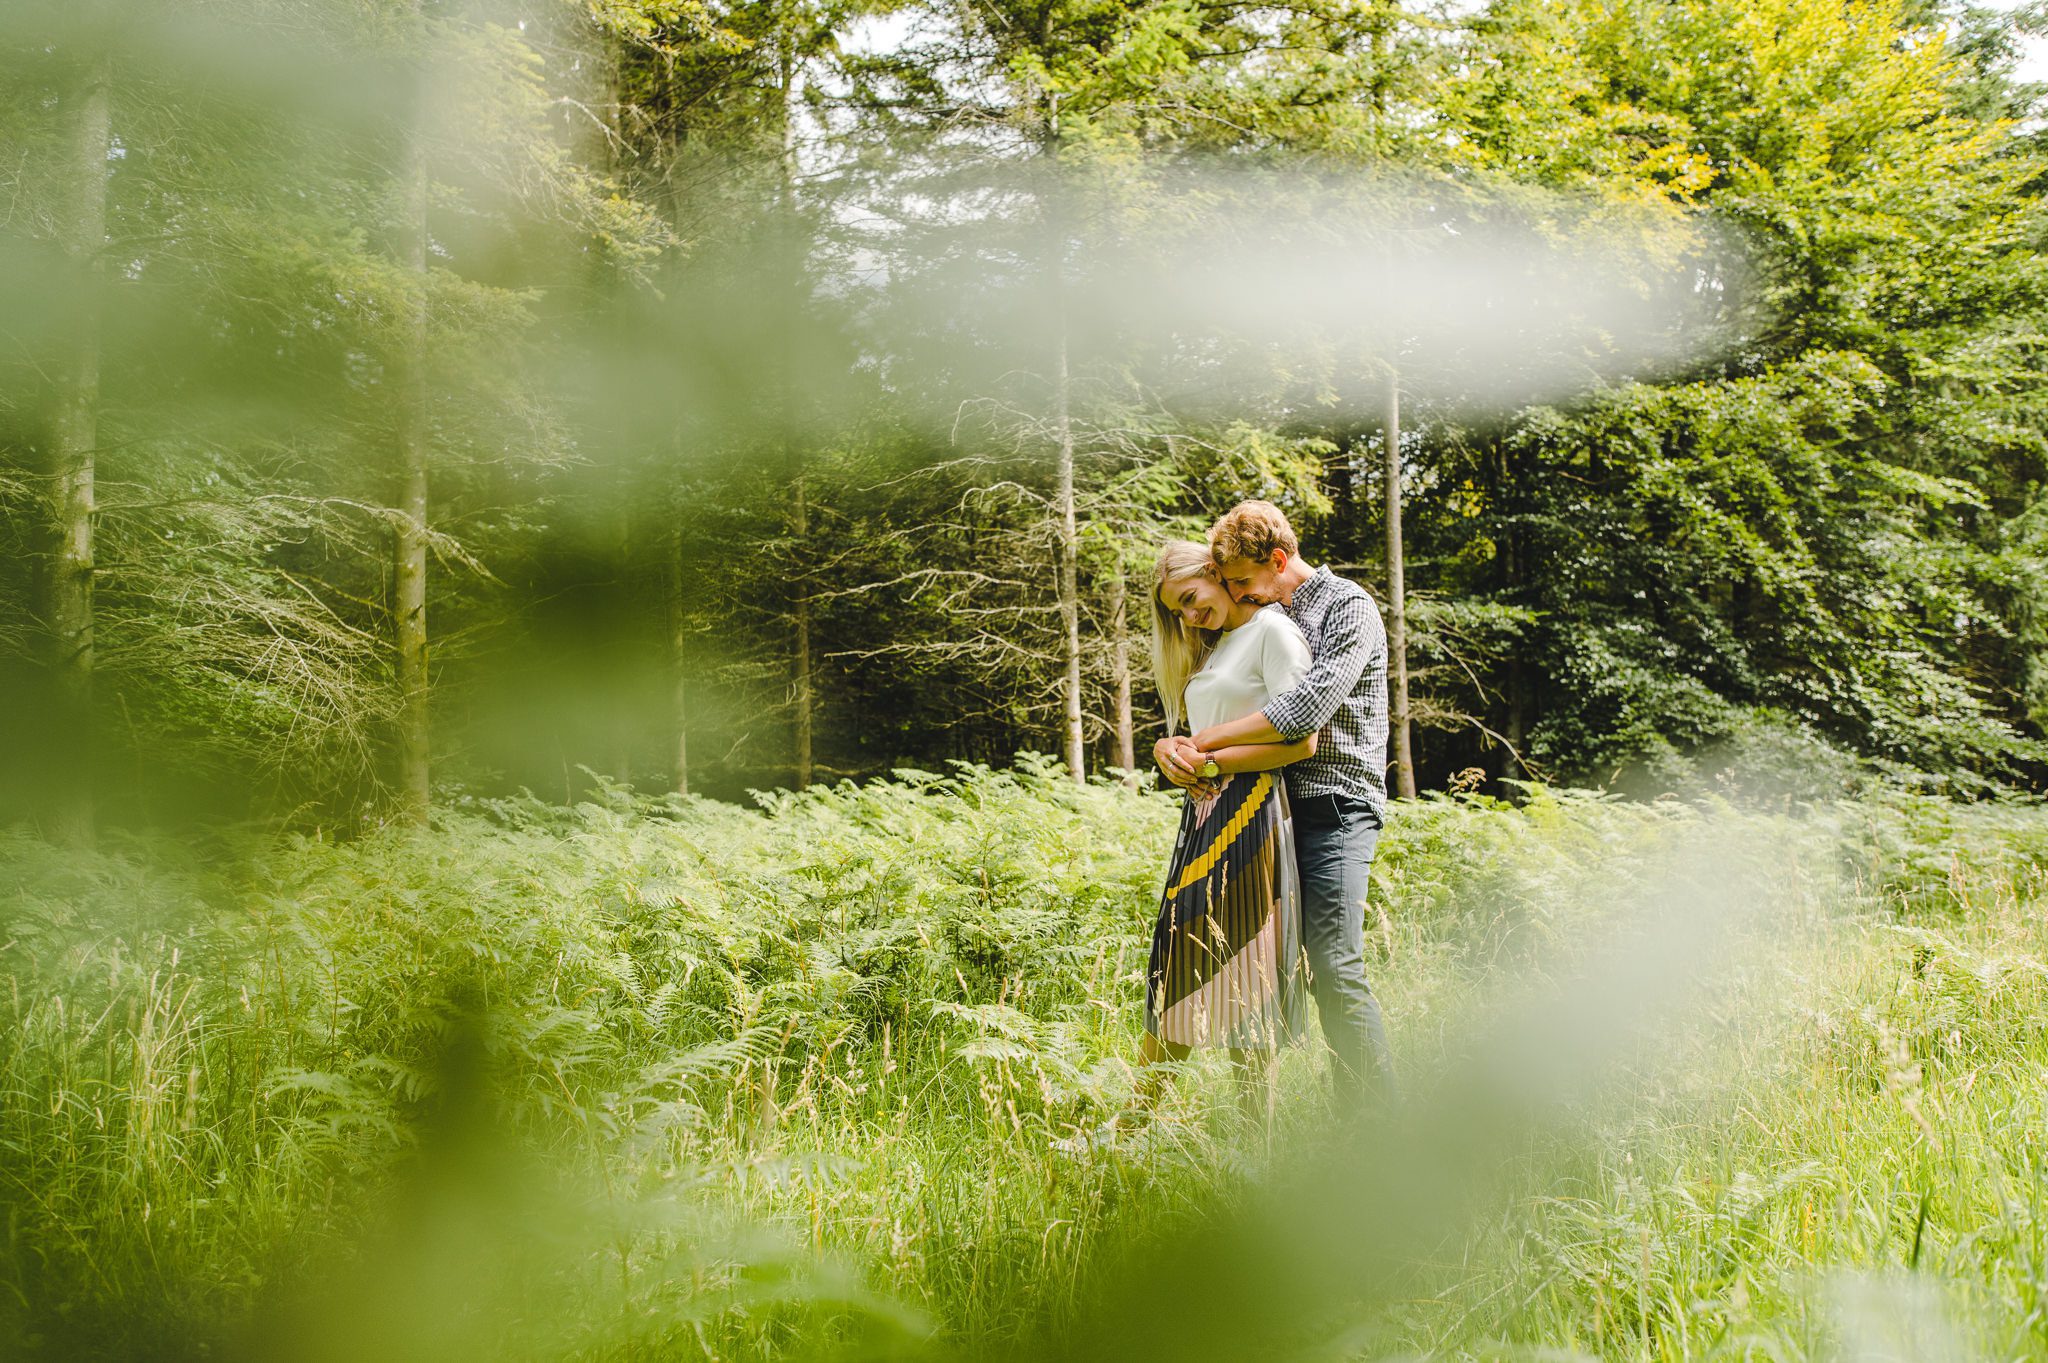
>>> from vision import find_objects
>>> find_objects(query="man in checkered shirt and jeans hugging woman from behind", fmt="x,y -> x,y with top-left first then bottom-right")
1153,501 -> 1395,1099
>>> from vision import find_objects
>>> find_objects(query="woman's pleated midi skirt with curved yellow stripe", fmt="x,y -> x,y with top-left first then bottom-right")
1145,772 -> 1307,1050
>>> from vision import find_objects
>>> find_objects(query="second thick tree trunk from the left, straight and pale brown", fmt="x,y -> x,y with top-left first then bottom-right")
391,21 -> 430,823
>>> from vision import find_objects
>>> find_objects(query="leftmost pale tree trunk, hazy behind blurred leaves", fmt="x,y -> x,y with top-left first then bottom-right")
39,55 -> 113,845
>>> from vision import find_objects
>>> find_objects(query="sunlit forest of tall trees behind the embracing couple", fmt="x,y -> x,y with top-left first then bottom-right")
0,0 -> 2048,837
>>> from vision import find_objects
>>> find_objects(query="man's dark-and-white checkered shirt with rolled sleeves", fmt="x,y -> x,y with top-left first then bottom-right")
1266,567 -> 1386,823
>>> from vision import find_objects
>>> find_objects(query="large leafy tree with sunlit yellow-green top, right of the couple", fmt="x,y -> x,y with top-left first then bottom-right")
1449,4 -> 2042,774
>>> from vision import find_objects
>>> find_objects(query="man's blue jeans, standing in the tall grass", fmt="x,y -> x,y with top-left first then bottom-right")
1292,796 -> 1395,1099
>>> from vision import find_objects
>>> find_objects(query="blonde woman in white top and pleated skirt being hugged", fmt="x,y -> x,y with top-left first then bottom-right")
1143,540 -> 1315,1103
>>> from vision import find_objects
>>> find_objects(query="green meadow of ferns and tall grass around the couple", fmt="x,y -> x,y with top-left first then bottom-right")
0,763 -> 2048,1359
